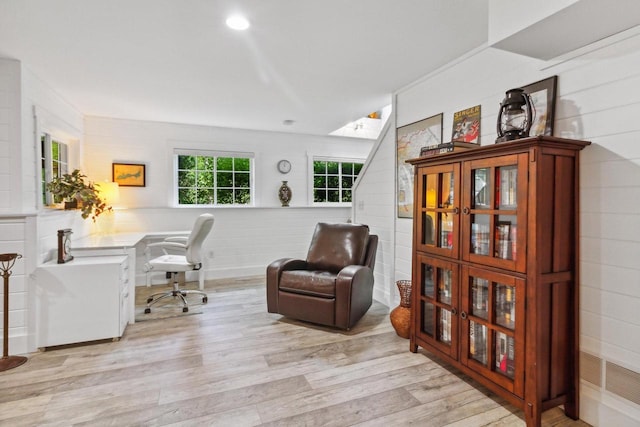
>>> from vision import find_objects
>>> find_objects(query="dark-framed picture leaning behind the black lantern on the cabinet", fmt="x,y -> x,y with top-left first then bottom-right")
522,76 -> 558,136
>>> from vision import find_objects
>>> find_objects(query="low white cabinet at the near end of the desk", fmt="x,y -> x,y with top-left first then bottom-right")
36,256 -> 129,348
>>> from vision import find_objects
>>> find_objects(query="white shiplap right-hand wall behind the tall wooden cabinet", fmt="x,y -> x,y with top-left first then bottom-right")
364,30 -> 640,426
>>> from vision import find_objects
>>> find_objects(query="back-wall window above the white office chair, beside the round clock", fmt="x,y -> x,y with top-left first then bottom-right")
174,150 -> 254,206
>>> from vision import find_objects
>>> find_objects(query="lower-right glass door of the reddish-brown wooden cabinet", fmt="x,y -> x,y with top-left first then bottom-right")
460,266 -> 525,396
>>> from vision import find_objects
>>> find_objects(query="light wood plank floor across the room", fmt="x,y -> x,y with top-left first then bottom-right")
0,277 -> 586,427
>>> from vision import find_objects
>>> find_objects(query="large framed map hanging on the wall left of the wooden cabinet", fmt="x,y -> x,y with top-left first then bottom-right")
396,113 -> 442,218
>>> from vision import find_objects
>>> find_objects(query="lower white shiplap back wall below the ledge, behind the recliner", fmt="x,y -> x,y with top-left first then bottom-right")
115,207 -> 351,285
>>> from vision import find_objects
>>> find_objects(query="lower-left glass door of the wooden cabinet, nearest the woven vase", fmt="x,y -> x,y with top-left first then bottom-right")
414,255 -> 458,357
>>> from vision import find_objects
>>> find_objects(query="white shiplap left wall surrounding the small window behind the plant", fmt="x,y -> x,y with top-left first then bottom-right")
0,59 -> 87,354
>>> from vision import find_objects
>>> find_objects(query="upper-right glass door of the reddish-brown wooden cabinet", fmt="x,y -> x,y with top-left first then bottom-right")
462,154 -> 528,272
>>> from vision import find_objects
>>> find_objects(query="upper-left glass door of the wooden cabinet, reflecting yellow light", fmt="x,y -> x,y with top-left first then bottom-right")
415,164 -> 460,258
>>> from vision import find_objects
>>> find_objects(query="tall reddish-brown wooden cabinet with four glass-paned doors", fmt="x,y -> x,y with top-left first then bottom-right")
409,137 -> 590,426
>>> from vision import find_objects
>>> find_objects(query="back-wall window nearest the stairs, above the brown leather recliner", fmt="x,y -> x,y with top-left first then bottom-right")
313,158 -> 363,203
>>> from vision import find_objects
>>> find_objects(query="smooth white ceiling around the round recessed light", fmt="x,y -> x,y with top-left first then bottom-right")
0,0 -> 488,135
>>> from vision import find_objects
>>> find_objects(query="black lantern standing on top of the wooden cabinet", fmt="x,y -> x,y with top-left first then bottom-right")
496,88 -> 533,143
